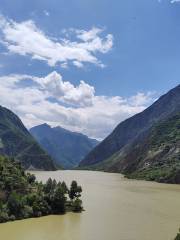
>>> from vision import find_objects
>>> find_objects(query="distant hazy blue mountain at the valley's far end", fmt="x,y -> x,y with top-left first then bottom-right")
30,124 -> 98,169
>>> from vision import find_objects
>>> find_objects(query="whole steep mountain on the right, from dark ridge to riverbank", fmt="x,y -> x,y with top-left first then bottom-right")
80,85 -> 180,182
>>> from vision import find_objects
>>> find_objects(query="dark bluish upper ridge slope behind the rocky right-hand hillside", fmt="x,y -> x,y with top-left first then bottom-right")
80,85 -> 180,167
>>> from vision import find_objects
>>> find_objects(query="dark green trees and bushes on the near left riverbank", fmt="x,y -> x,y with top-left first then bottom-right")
0,156 -> 82,222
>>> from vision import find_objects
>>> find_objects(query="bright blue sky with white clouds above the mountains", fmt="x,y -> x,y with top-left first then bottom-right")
0,0 -> 180,140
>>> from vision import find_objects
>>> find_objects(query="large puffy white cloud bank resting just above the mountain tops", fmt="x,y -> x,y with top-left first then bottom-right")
0,72 -> 154,139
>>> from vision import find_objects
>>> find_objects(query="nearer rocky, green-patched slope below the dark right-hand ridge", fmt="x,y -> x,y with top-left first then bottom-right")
88,113 -> 180,183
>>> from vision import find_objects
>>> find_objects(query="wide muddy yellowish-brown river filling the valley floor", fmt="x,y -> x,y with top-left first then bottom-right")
0,171 -> 180,240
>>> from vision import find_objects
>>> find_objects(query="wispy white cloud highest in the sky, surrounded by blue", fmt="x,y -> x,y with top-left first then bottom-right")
0,15 -> 113,67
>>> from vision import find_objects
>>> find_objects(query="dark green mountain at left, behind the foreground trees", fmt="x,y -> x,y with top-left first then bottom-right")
0,106 -> 55,170
